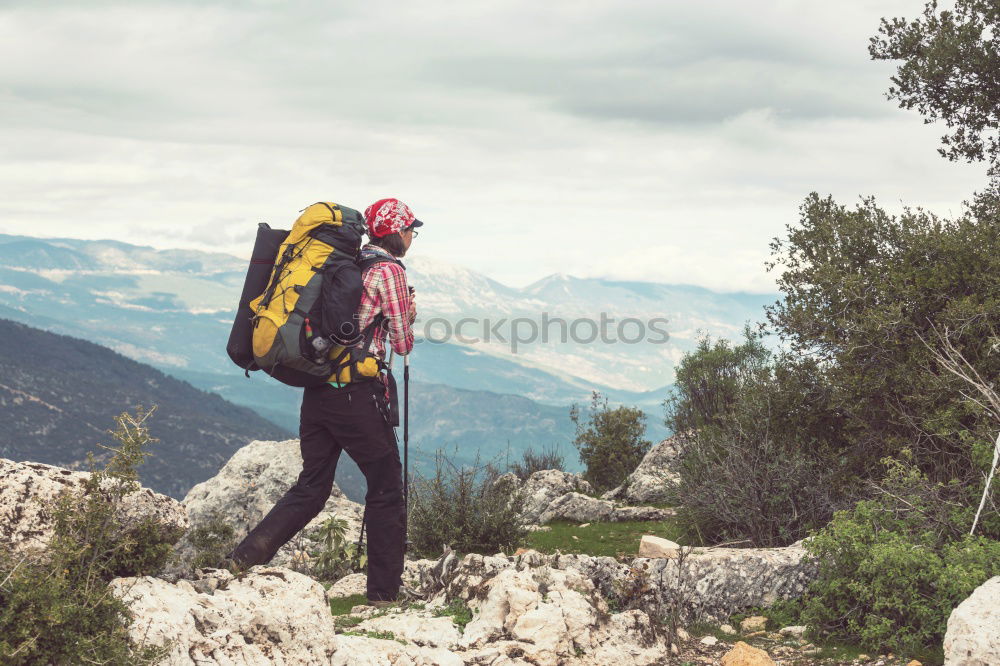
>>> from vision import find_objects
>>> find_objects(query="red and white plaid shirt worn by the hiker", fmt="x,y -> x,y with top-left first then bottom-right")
357,244 -> 413,361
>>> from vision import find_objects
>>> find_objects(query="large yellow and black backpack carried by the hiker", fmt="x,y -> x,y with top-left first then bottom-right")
227,202 -> 399,387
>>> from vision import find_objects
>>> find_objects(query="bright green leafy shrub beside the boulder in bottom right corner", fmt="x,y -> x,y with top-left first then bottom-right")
802,460 -> 1000,653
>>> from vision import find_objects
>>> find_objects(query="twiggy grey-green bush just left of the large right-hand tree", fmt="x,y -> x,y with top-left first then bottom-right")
665,328 -> 853,546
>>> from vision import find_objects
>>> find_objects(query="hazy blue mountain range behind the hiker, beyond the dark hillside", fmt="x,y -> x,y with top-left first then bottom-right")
0,234 -> 776,495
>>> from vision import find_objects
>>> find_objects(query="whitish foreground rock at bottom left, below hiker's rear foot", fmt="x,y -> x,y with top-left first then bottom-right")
111,567 -> 338,665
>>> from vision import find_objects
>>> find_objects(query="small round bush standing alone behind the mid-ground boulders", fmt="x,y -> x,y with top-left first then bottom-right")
569,391 -> 650,490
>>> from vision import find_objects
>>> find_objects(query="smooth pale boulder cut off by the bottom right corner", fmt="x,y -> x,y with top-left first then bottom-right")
944,576 -> 1000,666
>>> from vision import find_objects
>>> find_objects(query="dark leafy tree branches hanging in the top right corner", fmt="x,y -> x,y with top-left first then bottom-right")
868,0 -> 1000,177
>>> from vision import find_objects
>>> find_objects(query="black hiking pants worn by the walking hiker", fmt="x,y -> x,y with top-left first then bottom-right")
231,381 -> 406,601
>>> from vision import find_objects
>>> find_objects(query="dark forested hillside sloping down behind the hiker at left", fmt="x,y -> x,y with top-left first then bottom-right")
0,319 -> 292,499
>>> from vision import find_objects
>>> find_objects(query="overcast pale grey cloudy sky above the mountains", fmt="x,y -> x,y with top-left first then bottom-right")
0,0 -> 985,291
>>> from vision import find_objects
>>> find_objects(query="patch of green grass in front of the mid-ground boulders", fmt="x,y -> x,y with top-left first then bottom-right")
528,519 -> 695,557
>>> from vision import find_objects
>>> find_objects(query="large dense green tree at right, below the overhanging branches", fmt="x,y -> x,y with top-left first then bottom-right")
767,192 -> 1000,480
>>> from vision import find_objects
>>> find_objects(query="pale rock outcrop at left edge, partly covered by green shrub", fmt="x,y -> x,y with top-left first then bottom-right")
0,458 -> 188,554
